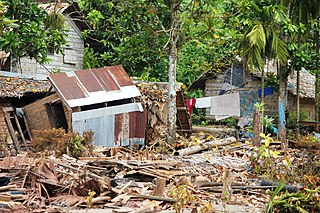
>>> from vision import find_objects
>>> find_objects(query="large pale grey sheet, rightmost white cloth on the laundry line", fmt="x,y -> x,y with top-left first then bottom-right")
210,92 -> 240,120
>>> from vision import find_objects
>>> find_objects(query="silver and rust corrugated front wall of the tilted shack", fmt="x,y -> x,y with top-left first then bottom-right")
72,103 -> 146,147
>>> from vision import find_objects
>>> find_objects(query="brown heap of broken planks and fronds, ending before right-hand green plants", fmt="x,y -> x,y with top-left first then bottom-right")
0,138 -> 274,212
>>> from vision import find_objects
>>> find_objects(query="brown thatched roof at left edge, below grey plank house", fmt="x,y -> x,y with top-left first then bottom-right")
0,71 -> 51,98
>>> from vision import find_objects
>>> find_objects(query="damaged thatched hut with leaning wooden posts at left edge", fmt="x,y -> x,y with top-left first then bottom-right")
0,71 -> 50,156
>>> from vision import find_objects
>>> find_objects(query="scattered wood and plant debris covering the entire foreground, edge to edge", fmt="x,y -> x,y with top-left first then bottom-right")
0,125 -> 320,212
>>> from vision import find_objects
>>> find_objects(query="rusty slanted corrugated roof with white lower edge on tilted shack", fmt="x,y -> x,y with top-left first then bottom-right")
49,65 -> 141,107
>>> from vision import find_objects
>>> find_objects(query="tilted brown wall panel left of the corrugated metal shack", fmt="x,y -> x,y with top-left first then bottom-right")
23,93 -> 59,132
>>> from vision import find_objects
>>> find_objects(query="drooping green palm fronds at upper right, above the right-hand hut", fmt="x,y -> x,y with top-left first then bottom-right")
231,0 -> 289,70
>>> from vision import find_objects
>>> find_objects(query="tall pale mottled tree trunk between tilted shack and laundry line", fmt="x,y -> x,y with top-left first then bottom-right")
167,0 -> 179,143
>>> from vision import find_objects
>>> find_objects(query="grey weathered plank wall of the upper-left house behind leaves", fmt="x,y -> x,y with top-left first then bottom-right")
13,16 -> 84,75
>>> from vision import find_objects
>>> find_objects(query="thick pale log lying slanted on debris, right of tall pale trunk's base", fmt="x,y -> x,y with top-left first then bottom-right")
175,137 -> 237,156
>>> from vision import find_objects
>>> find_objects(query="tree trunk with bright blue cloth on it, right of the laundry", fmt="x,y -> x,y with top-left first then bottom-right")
278,66 -> 288,149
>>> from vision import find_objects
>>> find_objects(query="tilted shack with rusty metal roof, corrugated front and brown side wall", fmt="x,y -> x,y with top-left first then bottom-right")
2,65 -> 146,152
